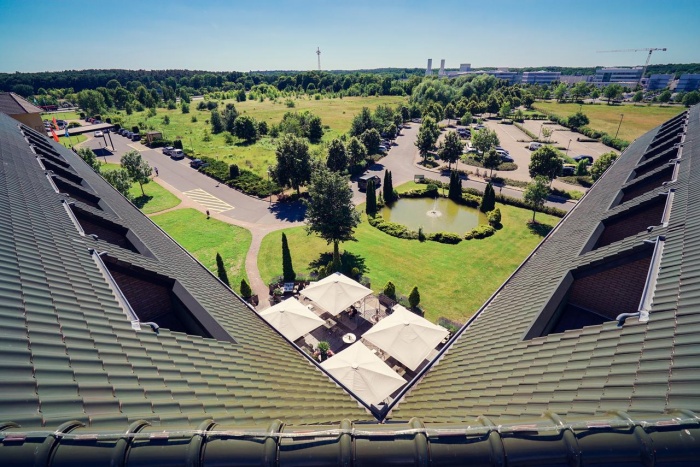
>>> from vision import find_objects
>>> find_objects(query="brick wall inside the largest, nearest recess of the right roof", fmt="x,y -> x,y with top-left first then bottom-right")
569,251 -> 652,320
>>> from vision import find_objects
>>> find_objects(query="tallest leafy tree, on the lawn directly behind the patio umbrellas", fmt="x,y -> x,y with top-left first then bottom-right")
305,166 -> 360,252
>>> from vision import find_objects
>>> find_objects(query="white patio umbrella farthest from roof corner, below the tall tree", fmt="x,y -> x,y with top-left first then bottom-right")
300,272 -> 372,316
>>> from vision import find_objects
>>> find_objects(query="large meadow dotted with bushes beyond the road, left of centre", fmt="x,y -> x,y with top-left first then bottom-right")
108,96 -> 406,177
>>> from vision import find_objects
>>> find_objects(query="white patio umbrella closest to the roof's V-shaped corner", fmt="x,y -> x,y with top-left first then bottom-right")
321,342 -> 406,405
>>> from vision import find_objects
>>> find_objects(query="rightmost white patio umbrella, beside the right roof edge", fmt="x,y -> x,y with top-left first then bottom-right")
362,305 -> 449,370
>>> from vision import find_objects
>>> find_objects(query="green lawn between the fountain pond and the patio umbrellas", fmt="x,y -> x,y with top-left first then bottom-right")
258,192 -> 559,323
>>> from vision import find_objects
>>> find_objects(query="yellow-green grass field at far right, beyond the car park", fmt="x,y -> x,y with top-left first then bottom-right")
534,102 -> 685,142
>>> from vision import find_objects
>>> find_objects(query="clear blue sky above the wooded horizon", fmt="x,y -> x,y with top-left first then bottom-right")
0,0 -> 700,72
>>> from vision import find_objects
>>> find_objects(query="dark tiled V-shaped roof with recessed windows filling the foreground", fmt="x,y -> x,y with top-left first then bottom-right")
0,106 -> 700,465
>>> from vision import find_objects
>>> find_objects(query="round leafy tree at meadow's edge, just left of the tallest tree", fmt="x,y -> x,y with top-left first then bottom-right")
274,134 -> 311,194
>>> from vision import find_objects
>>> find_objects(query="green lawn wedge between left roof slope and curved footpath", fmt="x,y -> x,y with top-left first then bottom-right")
151,208 -> 252,291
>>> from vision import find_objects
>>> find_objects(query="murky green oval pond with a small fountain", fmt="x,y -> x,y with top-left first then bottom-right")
379,198 -> 488,234
